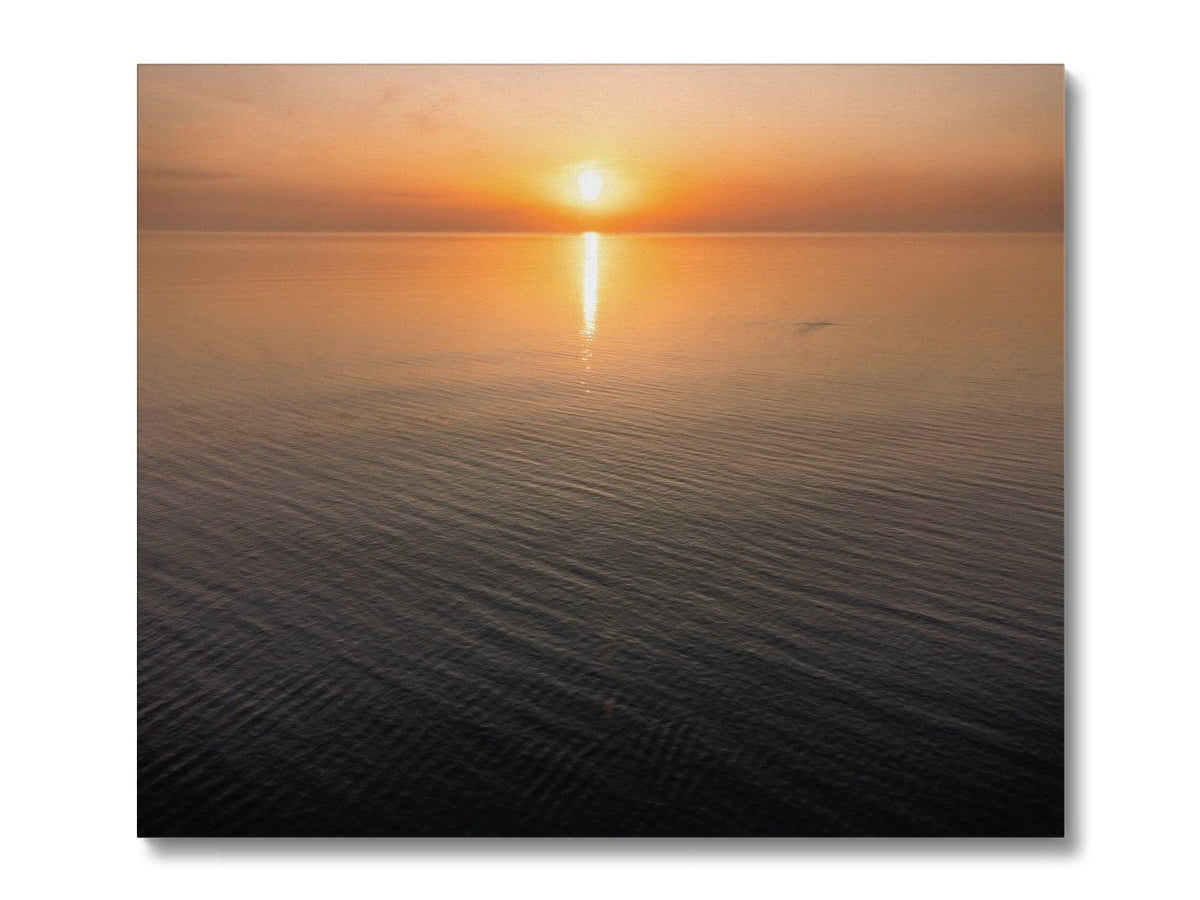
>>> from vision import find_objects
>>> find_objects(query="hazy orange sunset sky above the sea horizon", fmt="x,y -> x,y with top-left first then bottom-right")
138,66 -> 1063,232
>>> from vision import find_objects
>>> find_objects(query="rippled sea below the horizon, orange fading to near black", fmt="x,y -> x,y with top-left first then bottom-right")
138,234 -> 1063,835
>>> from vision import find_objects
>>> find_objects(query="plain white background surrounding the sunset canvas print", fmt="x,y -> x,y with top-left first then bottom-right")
0,0 -> 1200,899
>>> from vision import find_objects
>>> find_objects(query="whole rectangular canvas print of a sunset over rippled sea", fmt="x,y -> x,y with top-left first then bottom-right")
137,65 -> 1064,838
